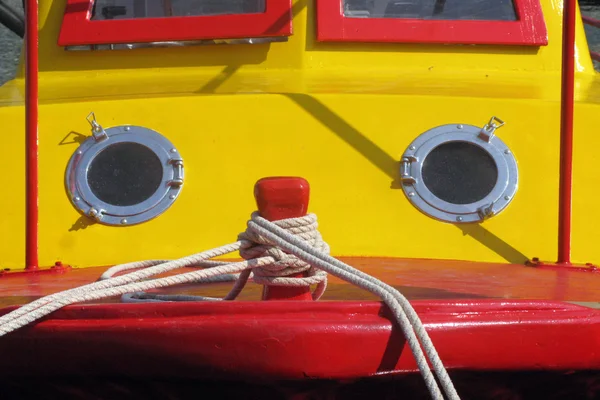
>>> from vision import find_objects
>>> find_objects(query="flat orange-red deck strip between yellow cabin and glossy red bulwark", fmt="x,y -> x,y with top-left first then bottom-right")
5,257 -> 600,304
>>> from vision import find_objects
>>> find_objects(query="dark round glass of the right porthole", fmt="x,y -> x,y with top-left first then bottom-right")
421,142 -> 498,204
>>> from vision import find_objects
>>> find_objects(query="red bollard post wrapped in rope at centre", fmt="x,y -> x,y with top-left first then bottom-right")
254,177 -> 312,300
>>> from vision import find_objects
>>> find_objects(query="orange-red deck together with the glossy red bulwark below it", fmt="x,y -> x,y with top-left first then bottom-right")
0,258 -> 600,380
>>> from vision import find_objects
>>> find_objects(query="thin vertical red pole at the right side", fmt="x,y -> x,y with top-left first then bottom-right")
557,0 -> 577,265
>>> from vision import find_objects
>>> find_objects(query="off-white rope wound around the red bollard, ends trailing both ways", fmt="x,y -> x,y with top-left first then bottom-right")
0,213 -> 459,400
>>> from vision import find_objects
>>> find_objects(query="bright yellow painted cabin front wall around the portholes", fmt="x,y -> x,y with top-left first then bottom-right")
0,0 -> 600,268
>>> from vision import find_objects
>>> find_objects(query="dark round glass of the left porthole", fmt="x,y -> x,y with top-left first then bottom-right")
87,142 -> 163,206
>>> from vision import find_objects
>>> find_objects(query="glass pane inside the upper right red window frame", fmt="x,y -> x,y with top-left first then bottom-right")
344,0 -> 517,21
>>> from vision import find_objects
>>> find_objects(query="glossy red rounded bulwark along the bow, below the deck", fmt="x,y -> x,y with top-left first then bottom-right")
0,300 -> 600,380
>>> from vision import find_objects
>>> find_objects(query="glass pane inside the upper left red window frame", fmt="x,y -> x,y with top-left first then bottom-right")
92,0 -> 265,20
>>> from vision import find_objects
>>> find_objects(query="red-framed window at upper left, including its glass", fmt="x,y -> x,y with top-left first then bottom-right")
58,0 -> 292,46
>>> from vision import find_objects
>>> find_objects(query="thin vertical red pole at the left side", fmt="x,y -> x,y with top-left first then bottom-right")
25,0 -> 39,271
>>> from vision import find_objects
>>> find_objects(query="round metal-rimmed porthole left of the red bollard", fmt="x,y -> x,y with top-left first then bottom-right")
66,114 -> 183,226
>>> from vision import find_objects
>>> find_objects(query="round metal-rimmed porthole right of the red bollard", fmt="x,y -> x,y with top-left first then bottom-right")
400,117 -> 518,223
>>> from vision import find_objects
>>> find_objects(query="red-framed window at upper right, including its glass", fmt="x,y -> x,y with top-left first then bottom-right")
317,0 -> 548,46
